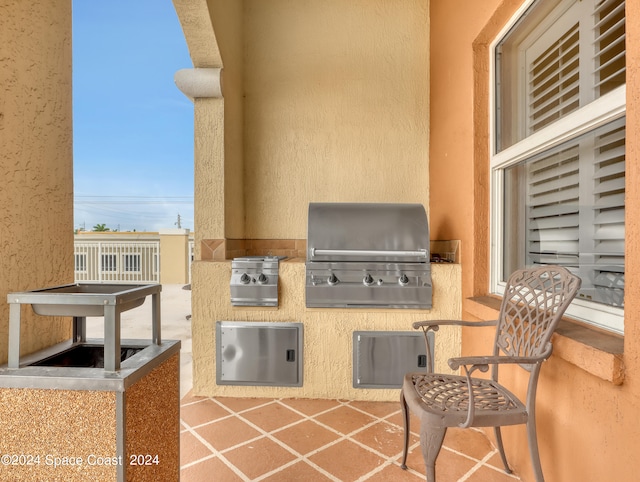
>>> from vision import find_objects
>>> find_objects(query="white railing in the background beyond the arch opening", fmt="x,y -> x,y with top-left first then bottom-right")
74,241 -> 160,283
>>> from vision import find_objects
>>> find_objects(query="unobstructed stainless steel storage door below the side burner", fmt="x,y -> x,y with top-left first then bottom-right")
216,321 -> 303,387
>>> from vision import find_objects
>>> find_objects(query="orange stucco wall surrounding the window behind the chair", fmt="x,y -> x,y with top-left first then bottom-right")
430,0 -> 640,482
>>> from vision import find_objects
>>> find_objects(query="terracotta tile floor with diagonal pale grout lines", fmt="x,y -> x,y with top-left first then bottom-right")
180,394 -> 519,482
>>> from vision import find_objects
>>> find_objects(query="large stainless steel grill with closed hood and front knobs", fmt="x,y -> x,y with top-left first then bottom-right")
306,203 -> 432,309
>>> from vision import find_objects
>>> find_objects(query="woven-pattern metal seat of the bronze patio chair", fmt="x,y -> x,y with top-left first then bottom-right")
403,373 -> 527,427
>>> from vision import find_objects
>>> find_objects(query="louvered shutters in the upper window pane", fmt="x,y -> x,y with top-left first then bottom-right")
524,0 -> 626,135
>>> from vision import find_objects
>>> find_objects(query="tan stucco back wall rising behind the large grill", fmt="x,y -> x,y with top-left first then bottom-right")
240,0 -> 429,239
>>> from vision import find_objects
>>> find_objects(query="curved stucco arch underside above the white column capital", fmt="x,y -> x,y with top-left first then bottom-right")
173,0 -> 223,68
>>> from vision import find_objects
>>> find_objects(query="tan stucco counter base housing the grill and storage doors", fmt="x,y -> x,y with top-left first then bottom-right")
192,258 -> 462,401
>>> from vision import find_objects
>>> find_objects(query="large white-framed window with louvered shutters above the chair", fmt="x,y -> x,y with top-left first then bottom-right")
492,0 -> 626,332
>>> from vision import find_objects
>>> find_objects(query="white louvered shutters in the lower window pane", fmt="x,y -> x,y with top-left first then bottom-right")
526,119 -> 625,306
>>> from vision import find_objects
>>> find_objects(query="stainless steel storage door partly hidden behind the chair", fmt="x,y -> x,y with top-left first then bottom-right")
353,331 -> 433,388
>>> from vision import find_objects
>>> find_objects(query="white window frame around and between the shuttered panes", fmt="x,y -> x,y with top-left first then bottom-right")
489,0 -> 626,334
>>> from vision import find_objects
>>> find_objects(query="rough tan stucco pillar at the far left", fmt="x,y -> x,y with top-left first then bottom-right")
0,0 -> 73,363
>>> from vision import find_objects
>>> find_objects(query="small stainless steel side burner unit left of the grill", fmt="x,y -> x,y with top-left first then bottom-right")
230,256 -> 285,306
